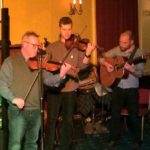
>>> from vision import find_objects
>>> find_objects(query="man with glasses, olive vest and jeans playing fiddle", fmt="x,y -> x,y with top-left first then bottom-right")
0,32 -> 70,150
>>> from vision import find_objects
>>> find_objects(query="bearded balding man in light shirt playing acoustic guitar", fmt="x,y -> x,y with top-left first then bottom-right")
99,30 -> 144,149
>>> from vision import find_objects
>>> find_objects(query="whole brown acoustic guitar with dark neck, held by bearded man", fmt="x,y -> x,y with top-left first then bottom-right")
100,53 -> 150,87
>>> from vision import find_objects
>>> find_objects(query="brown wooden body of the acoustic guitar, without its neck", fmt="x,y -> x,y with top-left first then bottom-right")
100,56 -> 125,87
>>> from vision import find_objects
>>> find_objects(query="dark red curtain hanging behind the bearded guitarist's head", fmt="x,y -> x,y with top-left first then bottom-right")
96,0 -> 139,51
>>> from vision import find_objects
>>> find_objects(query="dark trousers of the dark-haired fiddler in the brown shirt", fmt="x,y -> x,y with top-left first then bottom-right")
45,92 -> 76,150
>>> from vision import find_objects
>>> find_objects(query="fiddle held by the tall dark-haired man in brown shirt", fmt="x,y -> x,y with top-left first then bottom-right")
65,34 -> 90,51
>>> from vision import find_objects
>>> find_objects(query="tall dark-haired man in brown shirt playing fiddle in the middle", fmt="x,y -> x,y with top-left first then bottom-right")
45,17 -> 95,150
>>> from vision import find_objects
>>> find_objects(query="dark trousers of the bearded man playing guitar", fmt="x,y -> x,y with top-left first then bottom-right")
110,87 -> 140,143
